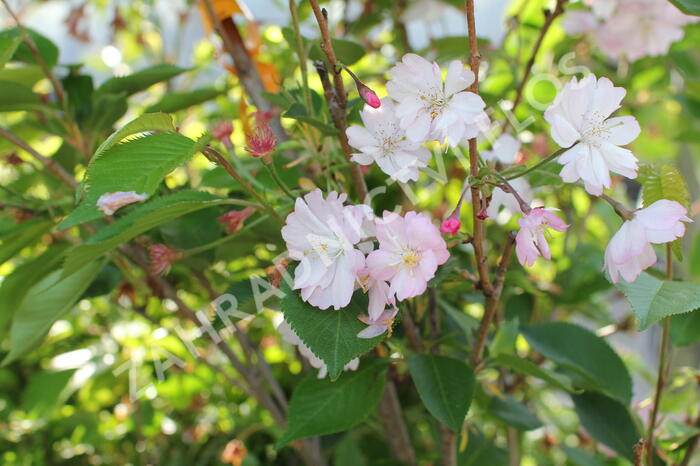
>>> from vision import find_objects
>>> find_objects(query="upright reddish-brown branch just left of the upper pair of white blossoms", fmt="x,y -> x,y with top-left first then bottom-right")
309,0 -> 367,202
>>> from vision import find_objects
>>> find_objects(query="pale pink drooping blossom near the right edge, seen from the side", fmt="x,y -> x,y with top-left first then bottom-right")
603,199 -> 692,283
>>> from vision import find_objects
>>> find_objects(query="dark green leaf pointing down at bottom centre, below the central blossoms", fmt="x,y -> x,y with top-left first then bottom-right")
408,353 -> 474,433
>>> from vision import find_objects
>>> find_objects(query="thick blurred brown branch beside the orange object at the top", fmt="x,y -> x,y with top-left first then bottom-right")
204,0 -> 289,142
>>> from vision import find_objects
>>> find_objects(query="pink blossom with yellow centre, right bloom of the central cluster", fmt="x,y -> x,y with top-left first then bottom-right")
367,212 -> 450,301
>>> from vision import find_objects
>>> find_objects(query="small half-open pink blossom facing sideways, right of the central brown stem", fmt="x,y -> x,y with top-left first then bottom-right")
515,207 -> 569,267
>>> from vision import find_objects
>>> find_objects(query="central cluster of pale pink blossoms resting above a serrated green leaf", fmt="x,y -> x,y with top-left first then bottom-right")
282,189 -> 449,338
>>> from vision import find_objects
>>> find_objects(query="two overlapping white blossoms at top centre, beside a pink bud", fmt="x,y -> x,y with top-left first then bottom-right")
347,53 -> 489,183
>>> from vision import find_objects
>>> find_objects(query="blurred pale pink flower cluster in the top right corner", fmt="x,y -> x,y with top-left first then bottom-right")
563,0 -> 697,61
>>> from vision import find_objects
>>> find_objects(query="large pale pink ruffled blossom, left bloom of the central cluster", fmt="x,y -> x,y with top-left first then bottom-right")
282,189 -> 367,309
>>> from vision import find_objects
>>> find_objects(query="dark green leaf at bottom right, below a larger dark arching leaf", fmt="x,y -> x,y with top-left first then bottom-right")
571,392 -> 639,460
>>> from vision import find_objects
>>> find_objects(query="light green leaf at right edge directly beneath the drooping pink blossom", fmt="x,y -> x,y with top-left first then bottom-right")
615,272 -> 700,331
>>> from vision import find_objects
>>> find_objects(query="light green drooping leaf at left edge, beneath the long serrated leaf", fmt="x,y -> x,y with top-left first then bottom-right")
2,261 -> 104,365
